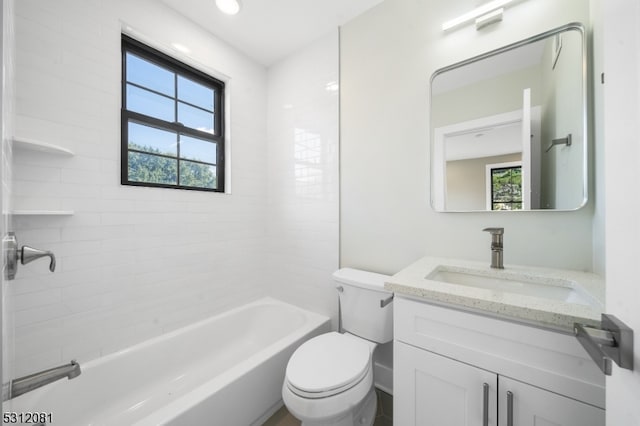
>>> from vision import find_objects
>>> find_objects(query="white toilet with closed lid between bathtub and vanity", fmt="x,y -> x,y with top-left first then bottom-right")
282,268 -> 393,426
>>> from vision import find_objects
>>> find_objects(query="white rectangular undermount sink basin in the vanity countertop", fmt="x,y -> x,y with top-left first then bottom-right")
425,265 -> 599,306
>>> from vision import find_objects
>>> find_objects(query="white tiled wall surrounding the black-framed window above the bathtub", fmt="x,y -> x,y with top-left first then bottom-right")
8,0 -> 268,377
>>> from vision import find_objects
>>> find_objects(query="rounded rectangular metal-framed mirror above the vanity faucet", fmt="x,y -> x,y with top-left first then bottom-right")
431,24 -> 588,211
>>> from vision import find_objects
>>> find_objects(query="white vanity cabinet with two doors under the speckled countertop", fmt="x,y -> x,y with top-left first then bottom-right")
394,297 -> 605,426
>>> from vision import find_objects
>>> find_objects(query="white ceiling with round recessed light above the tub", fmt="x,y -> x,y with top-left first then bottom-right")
161,0 -> 383,66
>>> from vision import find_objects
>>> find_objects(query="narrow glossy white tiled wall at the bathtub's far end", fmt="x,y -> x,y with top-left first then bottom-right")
267,30 -> 339,318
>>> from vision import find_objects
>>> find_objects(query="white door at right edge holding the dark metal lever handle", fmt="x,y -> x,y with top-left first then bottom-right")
598,0 -> 640,426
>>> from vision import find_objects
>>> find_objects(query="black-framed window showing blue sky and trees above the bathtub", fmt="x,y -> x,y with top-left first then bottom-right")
121,35 -> 224,192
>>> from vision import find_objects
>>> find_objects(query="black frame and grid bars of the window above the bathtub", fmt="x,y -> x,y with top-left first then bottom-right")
120,34 -> 226,193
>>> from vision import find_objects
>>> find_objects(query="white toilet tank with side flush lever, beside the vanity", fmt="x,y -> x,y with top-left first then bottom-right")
333,268 -> 393,343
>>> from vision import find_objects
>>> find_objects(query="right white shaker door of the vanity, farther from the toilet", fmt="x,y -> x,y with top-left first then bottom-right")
498,376 -> 605,426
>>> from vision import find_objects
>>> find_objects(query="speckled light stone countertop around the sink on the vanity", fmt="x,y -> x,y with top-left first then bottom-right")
385,257 -> 605,333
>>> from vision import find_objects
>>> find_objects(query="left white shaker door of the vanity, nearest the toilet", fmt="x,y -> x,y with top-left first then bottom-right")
393,341 -> 498,426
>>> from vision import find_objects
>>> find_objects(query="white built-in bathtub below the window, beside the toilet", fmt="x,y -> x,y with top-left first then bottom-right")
4,298 -> 330,426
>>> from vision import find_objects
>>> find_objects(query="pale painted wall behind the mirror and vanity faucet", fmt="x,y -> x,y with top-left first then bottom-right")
340,0 -> 593,273
